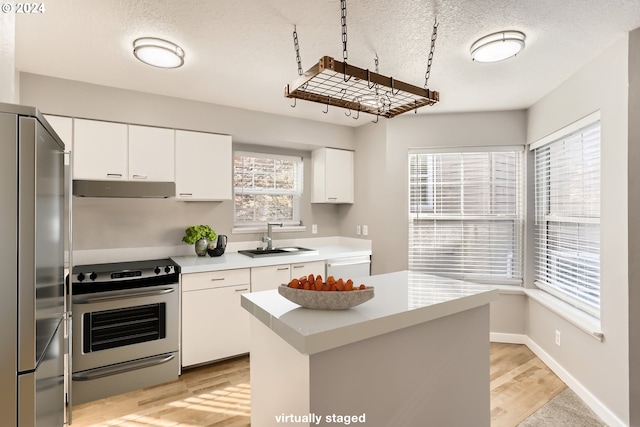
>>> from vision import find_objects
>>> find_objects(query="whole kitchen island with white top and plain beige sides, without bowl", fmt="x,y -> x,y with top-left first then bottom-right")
241,271 -> 498,427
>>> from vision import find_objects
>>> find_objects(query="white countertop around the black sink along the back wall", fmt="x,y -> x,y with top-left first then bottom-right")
171,245 -> 371,273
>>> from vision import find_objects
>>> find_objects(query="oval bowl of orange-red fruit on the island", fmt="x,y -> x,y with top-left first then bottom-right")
278,274 -> 374,310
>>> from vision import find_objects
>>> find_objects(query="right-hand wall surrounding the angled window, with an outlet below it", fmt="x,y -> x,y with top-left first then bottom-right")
526,36 -> 629,424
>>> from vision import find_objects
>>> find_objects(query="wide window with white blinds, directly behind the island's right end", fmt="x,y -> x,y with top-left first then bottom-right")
409,147 -> 524,284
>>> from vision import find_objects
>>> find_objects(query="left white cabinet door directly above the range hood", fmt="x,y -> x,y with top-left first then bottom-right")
72,119 -> 128,180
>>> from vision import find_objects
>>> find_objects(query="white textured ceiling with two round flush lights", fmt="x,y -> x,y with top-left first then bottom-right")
16,0 -> 640,126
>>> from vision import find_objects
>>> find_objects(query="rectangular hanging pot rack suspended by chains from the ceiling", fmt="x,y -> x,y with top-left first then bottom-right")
284,0 -> 440,123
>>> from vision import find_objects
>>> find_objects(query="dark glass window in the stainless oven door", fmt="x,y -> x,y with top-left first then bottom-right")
82,303 -> 166,353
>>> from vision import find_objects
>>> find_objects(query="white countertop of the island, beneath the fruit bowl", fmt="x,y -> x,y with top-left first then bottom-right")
241,271 -> 498,354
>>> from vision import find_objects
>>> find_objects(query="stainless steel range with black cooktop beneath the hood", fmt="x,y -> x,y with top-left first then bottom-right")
71,259 -> 180,404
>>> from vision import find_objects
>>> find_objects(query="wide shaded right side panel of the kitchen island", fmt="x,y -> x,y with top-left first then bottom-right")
309,304 -> 491,427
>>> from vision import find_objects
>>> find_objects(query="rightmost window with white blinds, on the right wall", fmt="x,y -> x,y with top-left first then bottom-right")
532,120 -> 600,317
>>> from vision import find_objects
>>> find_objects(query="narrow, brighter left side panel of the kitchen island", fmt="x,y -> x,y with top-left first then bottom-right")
249,316 -> 310,427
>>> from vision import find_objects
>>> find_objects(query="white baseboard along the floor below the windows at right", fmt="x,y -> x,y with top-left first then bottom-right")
490,332 -> 627,427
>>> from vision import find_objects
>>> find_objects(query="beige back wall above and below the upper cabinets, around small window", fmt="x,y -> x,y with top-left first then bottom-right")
20,73 -> 355,250
